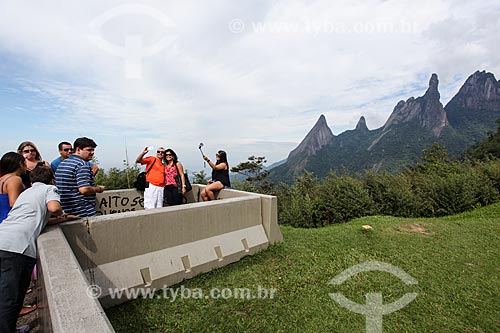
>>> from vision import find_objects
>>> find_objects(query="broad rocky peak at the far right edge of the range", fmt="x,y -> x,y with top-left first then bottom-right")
446,71 -> 500,111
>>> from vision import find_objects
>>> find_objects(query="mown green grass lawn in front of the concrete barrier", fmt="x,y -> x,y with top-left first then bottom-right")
106,204 -> 500,333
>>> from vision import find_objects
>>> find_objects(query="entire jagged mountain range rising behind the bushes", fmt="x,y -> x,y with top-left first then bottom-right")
270,71 -> 500,182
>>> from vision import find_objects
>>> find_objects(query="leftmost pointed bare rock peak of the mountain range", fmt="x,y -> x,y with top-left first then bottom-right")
288,115 -> 334,160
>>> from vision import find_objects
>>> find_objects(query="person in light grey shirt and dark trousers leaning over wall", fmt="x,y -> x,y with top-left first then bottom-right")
0,163 -> 79,332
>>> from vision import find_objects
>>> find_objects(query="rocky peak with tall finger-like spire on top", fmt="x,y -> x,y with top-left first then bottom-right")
382,74 -> 448,137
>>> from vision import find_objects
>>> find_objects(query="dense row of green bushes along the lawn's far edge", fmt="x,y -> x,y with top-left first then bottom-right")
277,150 -> 500,228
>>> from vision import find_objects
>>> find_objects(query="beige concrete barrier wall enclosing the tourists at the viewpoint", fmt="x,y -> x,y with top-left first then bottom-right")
38,184 -> 282,332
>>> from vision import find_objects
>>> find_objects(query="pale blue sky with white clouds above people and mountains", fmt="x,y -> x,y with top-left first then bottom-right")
0,0 -> 500,173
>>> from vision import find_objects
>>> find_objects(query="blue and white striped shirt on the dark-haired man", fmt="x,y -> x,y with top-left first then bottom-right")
56,154 -> 96,217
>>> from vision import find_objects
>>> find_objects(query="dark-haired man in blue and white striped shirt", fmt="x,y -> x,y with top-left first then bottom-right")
56,137 -> 104,217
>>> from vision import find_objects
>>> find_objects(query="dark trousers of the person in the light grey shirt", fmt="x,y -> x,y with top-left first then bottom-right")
0,250 -> 36,333
